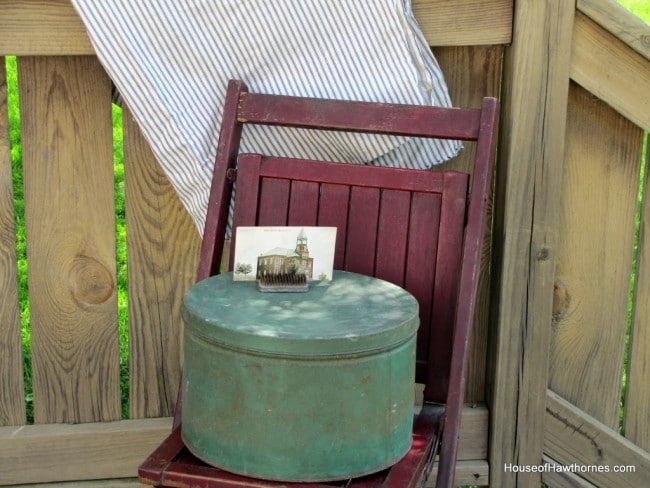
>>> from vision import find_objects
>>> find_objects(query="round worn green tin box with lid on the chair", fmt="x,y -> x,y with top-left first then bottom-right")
183,272 -> 419,481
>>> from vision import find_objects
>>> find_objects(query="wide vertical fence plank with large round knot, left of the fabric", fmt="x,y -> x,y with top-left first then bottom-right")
18,57 -> 120,423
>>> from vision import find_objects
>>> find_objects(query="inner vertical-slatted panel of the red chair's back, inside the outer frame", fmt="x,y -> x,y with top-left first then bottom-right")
230,154 -> 468,403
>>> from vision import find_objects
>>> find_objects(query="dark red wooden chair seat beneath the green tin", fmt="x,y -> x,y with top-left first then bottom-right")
138,404 -> 444,488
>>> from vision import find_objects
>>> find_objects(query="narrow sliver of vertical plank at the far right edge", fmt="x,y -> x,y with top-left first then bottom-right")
623,138 -> 650,451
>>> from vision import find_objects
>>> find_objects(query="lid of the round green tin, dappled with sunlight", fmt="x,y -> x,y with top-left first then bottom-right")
182,271 -> 419,356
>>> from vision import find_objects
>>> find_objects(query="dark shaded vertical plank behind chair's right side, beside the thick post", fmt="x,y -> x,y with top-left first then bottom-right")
433,46 -> 504,402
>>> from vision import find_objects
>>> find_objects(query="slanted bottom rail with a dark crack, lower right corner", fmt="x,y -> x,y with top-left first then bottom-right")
544,390 -> 650,488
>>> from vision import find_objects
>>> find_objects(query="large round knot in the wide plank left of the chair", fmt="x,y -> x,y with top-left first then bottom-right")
69,256 -> 115,305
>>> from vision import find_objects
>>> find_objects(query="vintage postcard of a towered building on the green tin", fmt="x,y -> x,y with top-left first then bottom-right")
233,227 -> 336,281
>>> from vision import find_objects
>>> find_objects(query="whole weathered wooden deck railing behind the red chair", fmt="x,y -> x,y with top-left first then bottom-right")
0,0 -> 650,487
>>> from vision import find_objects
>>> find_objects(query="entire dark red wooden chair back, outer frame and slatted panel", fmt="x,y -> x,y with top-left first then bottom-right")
198,81 -> 498,480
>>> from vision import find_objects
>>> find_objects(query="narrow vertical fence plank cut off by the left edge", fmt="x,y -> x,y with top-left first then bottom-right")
0,57 -> 25,425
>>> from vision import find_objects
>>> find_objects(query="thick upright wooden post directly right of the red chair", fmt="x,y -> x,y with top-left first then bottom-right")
489,0 -> 575,488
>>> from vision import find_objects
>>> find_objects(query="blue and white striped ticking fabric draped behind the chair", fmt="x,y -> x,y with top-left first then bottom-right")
72,0 -> 460,234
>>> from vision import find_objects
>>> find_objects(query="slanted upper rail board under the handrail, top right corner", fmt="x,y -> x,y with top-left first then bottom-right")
571,13 -> 650,130
